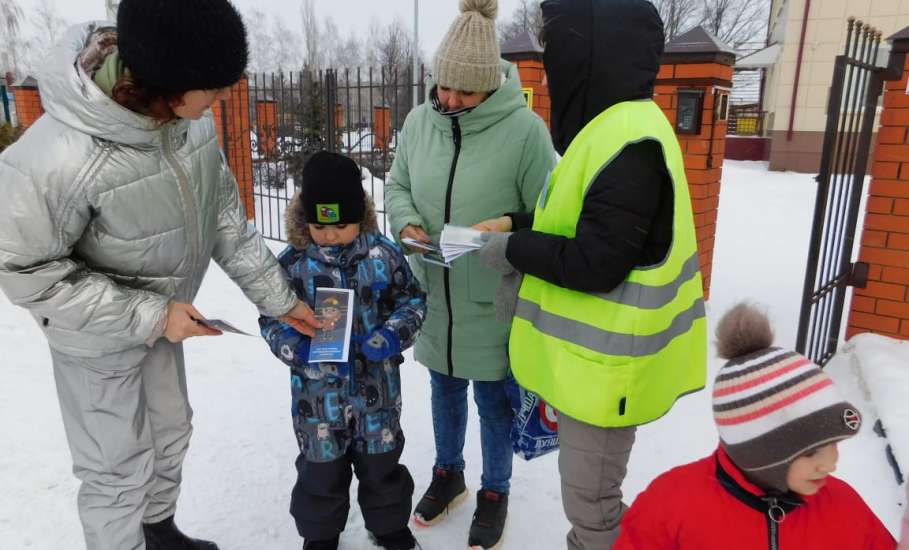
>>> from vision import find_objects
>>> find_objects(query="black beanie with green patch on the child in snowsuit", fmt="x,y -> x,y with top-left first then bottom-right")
300,151 -> 366,225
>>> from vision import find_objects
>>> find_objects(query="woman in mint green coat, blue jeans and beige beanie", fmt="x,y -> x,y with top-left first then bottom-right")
385,0 -> 555,548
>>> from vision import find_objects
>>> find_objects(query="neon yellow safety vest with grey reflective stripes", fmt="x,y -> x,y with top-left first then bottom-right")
509,101 -> 707,427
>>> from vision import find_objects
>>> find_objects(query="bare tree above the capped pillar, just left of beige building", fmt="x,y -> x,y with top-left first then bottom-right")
701,0 -> 770,47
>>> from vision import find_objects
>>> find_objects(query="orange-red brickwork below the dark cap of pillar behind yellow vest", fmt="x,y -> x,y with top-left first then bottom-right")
654,63 -> 733,298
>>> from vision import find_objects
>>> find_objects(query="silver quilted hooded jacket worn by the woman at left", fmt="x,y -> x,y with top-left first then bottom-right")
0,24 -> 296,367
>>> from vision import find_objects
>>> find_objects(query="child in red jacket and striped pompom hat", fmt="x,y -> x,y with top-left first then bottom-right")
613,304 -> 896,550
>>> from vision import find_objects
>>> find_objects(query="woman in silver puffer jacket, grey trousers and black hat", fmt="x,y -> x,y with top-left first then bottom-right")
0,0 -> 317,550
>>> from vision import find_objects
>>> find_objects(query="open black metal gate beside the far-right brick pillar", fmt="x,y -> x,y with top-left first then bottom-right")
793,18 -> 888,365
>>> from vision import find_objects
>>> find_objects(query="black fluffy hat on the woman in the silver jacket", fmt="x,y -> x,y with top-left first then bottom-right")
117,0 -> 249,92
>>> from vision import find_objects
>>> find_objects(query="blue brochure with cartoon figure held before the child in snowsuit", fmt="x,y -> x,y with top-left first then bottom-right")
309,288 -> 354,363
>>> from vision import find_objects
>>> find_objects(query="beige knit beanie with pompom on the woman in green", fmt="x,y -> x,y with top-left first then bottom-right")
433,0 -> 502,92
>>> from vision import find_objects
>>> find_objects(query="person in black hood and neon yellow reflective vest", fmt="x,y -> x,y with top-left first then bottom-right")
475,0 -> 707,550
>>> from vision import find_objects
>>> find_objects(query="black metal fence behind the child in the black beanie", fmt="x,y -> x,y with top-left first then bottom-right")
249,67 -> 426,241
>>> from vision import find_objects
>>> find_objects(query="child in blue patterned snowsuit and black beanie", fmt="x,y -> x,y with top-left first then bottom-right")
259,152 -> 426,550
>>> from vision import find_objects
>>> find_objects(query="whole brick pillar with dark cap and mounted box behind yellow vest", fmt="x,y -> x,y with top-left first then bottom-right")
654,27 -> 735,299
